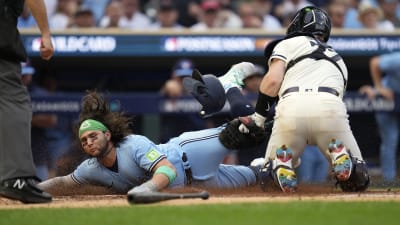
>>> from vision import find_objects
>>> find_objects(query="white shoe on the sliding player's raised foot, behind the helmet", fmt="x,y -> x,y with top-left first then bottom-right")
218,62 -> 256,91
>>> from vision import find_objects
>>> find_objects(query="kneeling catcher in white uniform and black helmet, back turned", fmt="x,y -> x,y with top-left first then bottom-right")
239,6 -> 369,192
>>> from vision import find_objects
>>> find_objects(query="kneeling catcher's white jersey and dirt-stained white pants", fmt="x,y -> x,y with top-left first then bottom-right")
265,36 -> 362,166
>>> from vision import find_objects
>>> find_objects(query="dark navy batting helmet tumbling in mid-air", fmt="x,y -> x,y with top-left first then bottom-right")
183,69 -> 226,117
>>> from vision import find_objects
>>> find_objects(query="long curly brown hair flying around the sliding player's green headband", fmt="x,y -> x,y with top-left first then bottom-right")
78,90 -> 133,146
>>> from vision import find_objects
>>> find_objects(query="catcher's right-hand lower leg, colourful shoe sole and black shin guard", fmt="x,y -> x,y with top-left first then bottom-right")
328,139 -> 370,192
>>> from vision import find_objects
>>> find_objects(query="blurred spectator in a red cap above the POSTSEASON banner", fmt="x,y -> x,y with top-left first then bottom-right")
191,0 -> 220,31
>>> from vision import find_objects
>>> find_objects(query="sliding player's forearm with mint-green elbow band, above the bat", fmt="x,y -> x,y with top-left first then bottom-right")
128,158 -> 176,194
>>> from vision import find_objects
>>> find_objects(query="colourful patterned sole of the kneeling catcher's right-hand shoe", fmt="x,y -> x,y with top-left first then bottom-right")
328,139 -> 353,181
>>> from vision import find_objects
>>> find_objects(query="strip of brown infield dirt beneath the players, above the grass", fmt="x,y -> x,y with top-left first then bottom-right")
0,187 -> 400,210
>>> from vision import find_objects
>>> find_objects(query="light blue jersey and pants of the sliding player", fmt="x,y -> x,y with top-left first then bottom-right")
72,126 -> 256,193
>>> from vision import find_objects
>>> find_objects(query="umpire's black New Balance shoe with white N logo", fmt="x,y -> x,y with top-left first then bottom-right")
0,178 -> 52,203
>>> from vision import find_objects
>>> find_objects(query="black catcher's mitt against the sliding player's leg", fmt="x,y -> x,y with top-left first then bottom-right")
219,117 -> 268,149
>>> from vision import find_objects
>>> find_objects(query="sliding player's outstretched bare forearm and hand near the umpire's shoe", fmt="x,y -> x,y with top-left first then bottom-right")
37,173 -> 80,194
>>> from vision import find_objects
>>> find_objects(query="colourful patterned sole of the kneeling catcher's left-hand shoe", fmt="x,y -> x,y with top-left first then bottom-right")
272,145 -> 297,192
